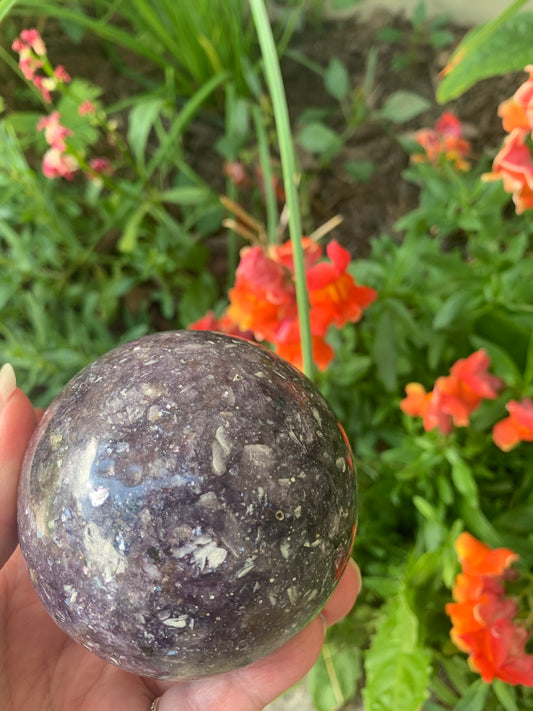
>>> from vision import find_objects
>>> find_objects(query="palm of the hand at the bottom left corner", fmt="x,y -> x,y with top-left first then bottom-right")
0,549 -> 159,711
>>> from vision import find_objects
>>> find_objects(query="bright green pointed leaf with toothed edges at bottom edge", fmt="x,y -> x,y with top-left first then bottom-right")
363,589 -> 430,711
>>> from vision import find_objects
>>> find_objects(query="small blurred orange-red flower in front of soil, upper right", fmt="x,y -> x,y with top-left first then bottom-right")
412,111 -> 471,170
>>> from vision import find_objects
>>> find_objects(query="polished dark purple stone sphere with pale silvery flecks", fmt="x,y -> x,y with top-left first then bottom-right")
18,331 -> 357,679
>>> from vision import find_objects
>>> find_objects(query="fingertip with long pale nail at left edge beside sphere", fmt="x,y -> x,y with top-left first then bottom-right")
0,366 -> 36,568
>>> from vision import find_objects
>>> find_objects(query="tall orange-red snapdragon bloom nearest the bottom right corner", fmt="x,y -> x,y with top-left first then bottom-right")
446,533 -> 533,686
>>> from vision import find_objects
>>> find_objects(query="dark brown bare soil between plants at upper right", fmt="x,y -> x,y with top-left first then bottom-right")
182,12 -> 524,258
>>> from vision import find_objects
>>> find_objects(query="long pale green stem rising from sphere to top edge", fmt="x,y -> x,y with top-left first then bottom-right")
249,0 -> 314,377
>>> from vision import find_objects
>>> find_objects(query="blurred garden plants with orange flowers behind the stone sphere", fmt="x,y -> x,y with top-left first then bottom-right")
0,0 -> 533,711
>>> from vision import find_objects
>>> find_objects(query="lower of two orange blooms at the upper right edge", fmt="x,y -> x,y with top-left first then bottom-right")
481,128 -> 533,215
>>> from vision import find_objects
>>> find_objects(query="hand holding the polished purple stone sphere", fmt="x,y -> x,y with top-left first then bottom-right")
0,366 -> 361,711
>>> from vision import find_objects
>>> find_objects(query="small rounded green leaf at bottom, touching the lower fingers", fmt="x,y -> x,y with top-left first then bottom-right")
307,644 -> 362,711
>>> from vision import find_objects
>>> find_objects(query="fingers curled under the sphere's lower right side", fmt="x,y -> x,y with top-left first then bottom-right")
158,562 -> 361,711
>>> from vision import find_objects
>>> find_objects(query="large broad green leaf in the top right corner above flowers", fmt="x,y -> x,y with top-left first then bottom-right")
437,12 -> 533,104
